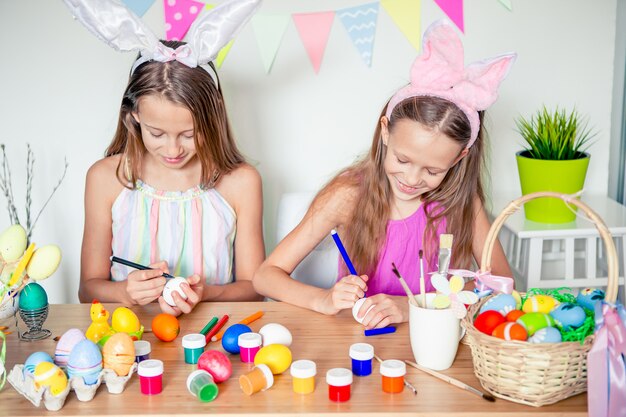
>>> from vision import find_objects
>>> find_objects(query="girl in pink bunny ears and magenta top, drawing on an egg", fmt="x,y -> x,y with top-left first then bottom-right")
253,22 -> 515,329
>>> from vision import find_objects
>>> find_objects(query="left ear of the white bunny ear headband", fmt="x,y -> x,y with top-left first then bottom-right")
63,0 -> 159,52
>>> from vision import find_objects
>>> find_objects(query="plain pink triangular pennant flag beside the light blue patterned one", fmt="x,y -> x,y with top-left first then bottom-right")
292,12 -> 335,74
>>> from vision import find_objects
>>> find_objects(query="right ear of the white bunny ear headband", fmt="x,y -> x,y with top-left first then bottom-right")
187,0 -> 261,64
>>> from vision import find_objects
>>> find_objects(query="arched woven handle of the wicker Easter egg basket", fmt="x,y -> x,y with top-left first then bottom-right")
480,191 -> 619,303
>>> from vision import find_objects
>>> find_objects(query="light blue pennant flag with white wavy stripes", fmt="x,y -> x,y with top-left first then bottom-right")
337,3 -> 378,67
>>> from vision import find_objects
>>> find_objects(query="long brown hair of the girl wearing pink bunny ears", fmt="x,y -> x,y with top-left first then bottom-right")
316,96 -> 485,274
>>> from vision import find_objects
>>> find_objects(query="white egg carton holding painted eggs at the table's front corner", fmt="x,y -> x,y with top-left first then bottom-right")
7,363 -> 137,411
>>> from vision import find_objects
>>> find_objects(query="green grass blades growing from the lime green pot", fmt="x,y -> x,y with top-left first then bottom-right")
515,106 -> 595,161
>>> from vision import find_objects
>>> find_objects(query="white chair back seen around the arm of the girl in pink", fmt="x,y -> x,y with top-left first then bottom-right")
276,192 -> 339,288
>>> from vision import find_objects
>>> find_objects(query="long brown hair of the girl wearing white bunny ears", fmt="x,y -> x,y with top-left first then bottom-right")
105,41 -> 245,188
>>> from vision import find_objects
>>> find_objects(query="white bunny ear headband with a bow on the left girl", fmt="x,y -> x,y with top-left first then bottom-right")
63,0 -> 261,84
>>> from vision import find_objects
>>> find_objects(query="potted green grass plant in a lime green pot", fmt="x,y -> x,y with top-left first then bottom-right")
516,106 -> 595,223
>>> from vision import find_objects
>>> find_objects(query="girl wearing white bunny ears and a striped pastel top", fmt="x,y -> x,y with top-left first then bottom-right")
71,0 -> 265,315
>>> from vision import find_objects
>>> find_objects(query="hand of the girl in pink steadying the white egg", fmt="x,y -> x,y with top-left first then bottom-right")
358,294 -> 409,329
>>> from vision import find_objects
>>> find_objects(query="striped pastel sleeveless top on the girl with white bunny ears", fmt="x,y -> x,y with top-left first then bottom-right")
111,180 -> 237,285
